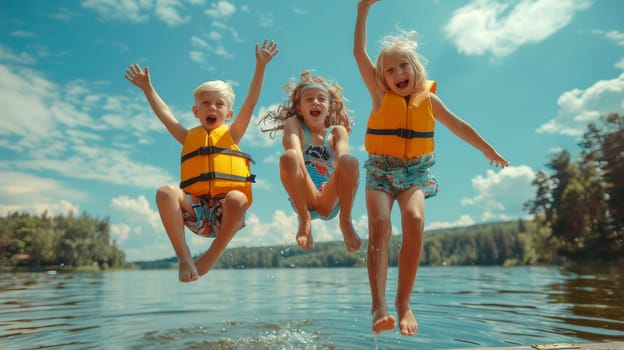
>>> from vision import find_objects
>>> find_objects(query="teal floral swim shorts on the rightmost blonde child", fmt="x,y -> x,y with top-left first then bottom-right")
364,153 -> 438,198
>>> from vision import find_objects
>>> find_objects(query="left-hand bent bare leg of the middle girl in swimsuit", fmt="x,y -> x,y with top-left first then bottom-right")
280,150 -> 316,249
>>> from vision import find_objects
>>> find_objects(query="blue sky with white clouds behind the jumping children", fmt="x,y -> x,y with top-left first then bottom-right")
0,0 -> 624,261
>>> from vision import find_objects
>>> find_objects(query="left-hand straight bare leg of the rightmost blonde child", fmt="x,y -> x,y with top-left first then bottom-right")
366,190 -> 396,333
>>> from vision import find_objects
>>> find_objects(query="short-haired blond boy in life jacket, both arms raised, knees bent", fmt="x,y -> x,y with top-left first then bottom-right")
126,40 -> 279,282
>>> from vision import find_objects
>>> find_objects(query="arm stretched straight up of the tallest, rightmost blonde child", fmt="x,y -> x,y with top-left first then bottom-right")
353,0 -> 384,111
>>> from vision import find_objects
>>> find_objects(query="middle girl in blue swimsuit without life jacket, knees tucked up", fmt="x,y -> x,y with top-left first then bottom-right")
260,71 -> 361,252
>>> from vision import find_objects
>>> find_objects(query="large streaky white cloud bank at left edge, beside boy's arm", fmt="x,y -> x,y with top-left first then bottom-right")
0,60 -> 175,188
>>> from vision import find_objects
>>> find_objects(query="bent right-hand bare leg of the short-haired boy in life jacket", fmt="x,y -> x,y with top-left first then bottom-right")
195,191 -> 247,276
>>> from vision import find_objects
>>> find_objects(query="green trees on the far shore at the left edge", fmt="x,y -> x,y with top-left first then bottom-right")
0,212 -> 126,270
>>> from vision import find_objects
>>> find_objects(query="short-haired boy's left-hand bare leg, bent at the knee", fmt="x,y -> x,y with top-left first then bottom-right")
156,185 -> 198,282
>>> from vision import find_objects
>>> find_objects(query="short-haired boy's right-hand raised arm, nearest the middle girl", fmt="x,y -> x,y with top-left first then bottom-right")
230,40 -> 279,143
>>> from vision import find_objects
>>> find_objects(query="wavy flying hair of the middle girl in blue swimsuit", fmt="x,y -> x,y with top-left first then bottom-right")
258,70 -> 353,138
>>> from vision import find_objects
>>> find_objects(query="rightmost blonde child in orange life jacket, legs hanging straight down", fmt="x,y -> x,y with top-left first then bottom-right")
353,0 -> 508,335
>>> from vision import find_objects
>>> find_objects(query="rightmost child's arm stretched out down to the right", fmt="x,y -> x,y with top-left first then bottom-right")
430,94 -> 509,168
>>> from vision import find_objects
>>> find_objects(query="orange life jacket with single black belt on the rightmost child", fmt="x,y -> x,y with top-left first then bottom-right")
364,80 -> 436,159
